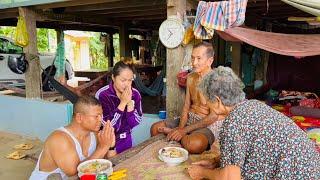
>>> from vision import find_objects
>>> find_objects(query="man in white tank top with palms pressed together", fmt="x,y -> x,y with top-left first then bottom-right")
30,96 -> 115,180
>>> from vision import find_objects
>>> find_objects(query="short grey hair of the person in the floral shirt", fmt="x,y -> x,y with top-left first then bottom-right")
199,66 -> 245,106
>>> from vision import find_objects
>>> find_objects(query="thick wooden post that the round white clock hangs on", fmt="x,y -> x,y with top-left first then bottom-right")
166,0 -> 186,118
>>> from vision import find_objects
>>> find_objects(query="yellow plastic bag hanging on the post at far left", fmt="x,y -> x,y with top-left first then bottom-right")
15,16 -> 29,47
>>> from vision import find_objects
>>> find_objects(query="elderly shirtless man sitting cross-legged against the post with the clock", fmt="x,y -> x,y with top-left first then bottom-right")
150,42 -> 215,153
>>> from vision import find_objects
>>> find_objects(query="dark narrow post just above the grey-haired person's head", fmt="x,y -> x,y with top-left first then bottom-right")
231,42 -> 241,78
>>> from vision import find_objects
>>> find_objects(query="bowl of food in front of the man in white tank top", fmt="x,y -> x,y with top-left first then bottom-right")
77,159 -> 113,177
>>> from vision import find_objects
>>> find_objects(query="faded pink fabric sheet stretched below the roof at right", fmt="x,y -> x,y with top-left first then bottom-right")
216,27 -> 320,56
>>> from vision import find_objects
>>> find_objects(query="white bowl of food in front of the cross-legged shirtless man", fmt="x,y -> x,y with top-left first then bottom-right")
159,147 -> 189,166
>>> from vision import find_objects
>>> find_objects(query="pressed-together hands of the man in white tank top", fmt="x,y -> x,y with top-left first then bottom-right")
98,120 -> 115,149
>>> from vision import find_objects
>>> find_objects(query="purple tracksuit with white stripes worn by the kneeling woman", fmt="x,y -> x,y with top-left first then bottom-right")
96,82 -> 142,153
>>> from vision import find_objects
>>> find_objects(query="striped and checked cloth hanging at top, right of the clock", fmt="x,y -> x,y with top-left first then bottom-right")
193,0 -> 248,39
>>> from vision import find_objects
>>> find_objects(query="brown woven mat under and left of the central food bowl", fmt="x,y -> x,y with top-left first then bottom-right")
114,140 -> 191,180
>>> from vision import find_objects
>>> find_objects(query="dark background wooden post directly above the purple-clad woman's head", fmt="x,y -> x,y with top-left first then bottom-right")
119,23 -> 130,57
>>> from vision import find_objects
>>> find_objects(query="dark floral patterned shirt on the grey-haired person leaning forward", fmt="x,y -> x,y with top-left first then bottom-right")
220,100 -> 320,180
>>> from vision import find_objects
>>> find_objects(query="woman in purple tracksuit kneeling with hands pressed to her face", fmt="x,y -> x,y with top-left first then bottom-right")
96,61 -> 142,153
